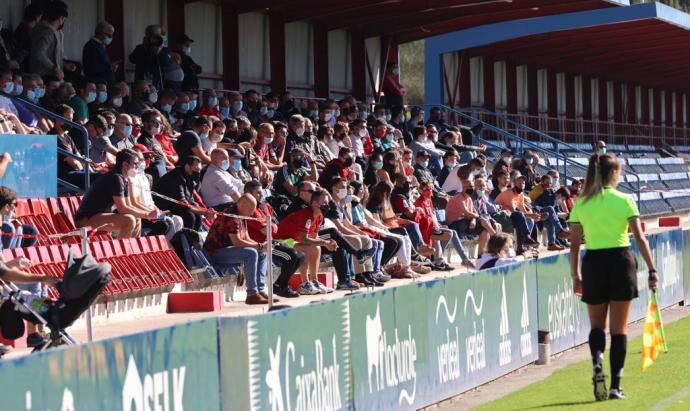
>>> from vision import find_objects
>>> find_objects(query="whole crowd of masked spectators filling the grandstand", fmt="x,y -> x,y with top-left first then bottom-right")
0,1 -> 580,304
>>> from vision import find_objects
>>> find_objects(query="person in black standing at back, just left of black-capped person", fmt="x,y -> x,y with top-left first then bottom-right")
129,24 -> 171,90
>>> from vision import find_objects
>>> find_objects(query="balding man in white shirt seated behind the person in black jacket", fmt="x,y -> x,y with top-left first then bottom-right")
199,148 -> 244,211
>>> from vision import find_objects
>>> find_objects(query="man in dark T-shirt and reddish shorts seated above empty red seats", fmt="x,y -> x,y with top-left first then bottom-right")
74,149 -> 159,238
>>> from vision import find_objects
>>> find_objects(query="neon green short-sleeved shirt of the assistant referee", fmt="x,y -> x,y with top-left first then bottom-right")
569,187 -> 640,250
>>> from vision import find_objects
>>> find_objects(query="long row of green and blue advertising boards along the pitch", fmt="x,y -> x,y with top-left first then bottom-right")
0,230 -> 690,410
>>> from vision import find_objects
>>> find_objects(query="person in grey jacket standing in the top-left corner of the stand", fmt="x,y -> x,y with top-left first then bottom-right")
29,0 -> 69,80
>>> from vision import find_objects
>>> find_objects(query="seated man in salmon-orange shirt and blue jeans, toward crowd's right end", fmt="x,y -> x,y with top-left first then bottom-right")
494,176 -> 541,254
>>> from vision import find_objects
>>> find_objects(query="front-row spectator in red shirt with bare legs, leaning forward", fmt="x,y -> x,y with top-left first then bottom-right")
276,190 -> 338,295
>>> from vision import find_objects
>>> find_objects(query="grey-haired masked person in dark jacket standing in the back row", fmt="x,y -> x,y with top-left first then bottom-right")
81,21 -> 119,86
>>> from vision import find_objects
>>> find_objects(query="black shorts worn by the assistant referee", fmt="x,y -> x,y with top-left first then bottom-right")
582,247 -> 638,304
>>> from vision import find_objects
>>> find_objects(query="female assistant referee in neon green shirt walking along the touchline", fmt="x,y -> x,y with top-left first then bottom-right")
570,154 -> 658,401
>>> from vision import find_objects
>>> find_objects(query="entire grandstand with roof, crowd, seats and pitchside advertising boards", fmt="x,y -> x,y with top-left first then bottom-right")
0,0 -> 690,410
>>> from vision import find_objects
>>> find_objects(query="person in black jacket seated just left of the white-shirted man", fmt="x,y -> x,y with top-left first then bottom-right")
153,156 -> 215,231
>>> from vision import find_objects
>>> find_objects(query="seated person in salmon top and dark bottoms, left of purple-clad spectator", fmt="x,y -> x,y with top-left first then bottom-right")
446,180 -> 496,254
